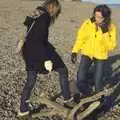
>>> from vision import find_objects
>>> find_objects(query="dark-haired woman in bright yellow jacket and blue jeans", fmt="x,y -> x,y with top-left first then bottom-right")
71,5 -> 116,101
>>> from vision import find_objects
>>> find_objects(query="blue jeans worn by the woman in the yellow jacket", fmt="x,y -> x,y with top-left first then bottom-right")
77,55 -> 105,94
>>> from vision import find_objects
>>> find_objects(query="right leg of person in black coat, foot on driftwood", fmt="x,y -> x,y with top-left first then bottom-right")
57,67 -> 70,100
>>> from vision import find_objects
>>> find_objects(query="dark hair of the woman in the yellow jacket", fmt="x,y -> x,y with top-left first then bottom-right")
91,4 -> 111,25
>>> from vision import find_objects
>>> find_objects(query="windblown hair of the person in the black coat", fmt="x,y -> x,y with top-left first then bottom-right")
41,0 -> 61,23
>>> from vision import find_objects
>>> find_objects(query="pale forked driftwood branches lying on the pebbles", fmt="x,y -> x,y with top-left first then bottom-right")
32,84 -> 119,120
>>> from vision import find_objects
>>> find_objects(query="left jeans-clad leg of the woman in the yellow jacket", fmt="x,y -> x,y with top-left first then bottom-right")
77,55 -> 92,94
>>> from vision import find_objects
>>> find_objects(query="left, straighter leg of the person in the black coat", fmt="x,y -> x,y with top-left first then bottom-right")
20,71 -> 37,112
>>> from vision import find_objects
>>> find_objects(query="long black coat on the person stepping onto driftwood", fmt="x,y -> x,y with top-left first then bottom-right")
22,8 -> 65,73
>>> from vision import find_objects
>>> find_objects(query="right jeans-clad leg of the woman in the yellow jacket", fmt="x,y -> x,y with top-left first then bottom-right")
94,59 -> 105,92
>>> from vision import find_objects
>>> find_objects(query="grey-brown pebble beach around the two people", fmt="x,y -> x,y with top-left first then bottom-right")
0,0 -> 120,120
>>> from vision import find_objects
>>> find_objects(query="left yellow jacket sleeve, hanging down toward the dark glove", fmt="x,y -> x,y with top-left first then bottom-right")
72,20 -> 88,53
